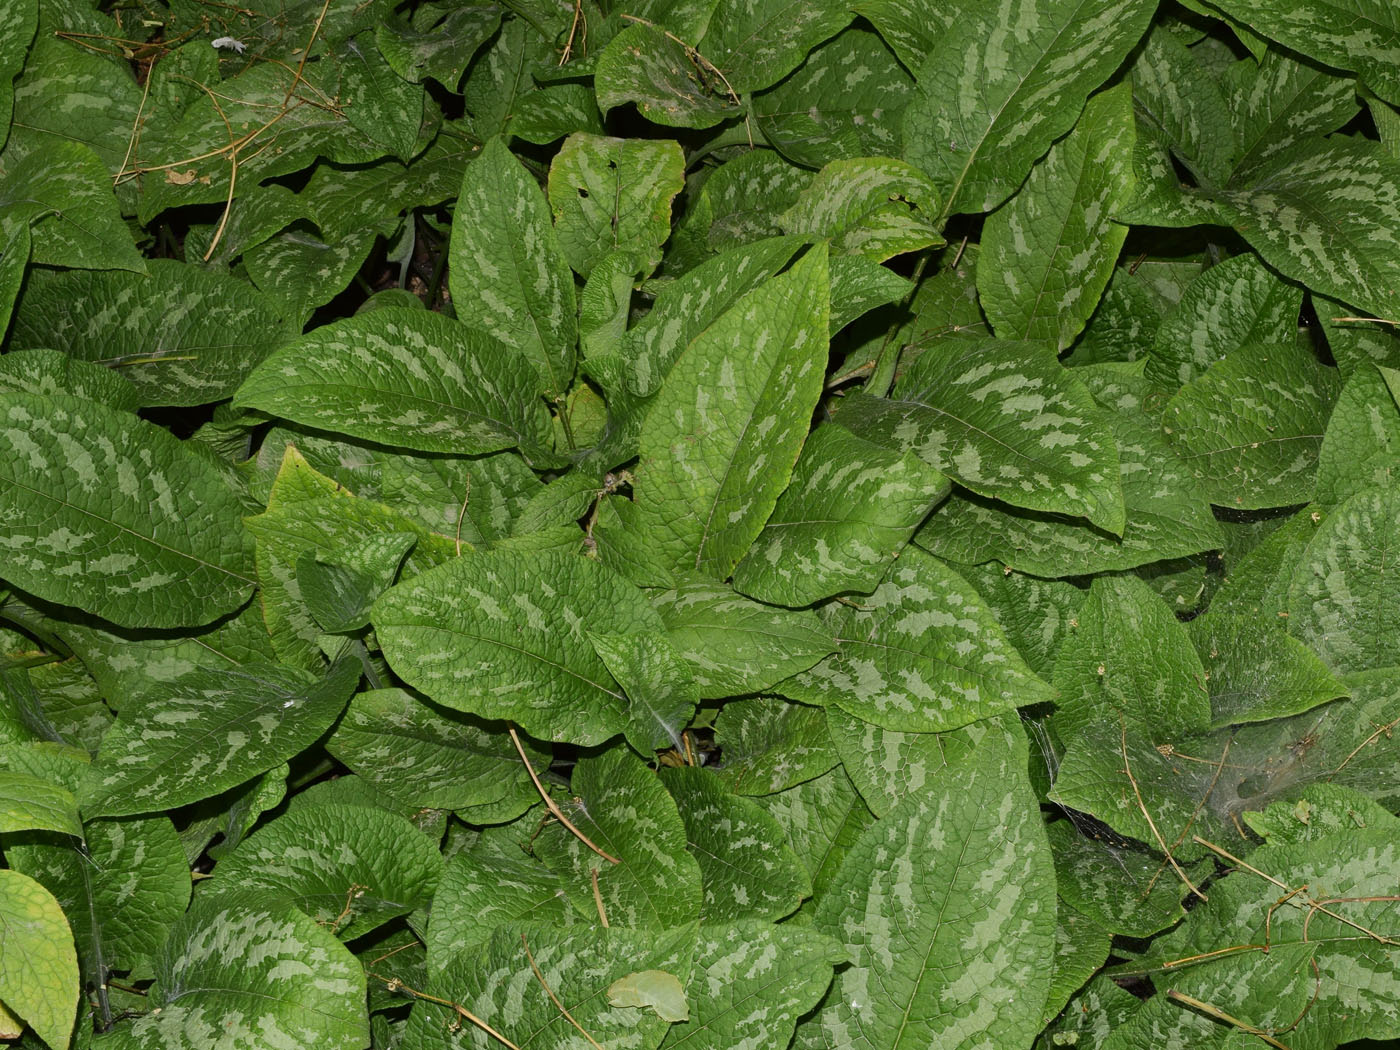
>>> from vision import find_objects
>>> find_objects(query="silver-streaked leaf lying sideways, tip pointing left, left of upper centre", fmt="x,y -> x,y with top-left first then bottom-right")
234,309 -> 549,458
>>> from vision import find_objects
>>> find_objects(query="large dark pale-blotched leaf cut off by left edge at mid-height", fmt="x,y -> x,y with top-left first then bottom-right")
0,393 -> 253,627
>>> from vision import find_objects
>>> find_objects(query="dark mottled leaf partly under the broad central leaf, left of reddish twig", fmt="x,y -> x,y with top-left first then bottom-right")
326,689 -> 549,812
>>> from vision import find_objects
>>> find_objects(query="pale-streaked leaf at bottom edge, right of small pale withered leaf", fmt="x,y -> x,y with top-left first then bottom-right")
661,920 -> 846,1050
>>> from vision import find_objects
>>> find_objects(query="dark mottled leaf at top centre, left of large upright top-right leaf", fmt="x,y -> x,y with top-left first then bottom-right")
750,24 -> 914,168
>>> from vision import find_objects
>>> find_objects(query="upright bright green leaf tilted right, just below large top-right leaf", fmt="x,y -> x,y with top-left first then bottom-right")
977,85 -> 1134,350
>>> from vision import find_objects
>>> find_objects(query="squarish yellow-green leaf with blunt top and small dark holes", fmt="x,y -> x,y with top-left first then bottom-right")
549,134 -> 685,277
